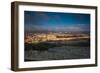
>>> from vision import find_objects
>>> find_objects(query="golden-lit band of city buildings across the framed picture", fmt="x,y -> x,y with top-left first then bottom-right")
25,33 -> 89,43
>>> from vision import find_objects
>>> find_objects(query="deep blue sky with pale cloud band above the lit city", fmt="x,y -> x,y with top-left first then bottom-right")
24,11 -> 90,32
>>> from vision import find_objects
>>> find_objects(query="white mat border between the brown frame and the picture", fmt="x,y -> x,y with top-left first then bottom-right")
18,5 -> 96,68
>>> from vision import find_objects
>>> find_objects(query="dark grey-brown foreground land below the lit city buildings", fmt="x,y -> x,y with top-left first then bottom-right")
24,39 -> 90,61
